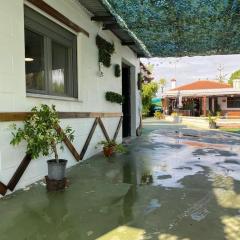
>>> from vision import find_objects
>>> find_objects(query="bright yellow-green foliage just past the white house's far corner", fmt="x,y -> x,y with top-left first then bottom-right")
142,82 -> 158,114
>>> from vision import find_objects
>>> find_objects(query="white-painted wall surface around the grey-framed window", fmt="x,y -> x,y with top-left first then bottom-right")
0,0 -> 139,192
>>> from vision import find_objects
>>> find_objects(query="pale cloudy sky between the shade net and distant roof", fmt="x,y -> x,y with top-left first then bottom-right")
141,54 -> 240,89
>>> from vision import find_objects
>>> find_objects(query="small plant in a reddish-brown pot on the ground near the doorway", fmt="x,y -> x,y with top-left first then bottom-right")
98,140 -> 126,158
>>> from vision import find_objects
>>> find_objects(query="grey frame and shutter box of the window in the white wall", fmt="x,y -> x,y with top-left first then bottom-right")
24,6 -> 78,98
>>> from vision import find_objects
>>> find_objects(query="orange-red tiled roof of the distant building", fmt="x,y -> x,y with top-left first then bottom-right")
170,80 -> 231,91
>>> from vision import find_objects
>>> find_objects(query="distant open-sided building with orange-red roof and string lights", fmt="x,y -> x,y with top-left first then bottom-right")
163,80 -> 240,116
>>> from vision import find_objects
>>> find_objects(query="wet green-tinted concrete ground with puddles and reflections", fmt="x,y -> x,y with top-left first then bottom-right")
0,123 -> 240,240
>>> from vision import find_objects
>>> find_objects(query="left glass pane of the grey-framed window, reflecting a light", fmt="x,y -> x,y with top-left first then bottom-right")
25,29 -> 45,90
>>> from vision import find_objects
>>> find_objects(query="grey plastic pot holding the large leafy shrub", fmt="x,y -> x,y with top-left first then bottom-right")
47,159 -> 67,181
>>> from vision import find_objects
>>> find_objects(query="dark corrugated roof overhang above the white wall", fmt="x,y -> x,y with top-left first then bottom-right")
78,0 -> 151,57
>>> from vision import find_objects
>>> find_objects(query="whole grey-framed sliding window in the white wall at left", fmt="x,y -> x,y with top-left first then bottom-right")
25,7 -> 77,98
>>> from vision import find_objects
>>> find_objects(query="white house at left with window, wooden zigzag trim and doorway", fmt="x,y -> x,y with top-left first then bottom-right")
0,0 -> 147,194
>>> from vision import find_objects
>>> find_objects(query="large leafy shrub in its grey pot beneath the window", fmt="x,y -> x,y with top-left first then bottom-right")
10,104 -> 74,180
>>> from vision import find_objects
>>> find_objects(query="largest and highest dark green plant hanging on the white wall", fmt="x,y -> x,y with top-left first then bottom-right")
96,35 -> 115,67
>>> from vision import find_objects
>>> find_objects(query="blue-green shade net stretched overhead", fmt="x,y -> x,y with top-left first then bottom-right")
103,0 -> 240,57
